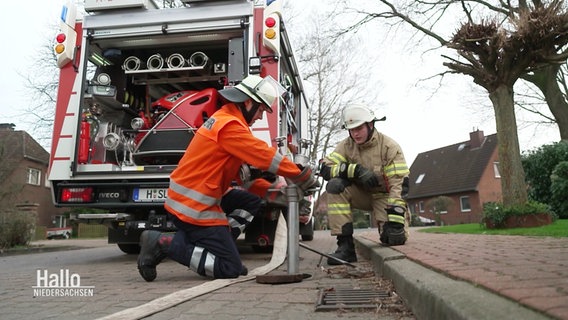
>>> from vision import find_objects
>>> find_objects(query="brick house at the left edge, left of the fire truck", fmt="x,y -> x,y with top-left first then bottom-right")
0,123 -> 65,227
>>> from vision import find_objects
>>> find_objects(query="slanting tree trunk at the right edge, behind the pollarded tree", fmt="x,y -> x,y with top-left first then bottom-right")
531,65 -> 568,140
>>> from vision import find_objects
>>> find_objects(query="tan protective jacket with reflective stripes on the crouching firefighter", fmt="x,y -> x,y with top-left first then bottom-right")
324,129 -> 410,206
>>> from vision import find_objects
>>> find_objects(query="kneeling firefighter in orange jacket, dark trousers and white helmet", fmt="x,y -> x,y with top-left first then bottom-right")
138,75 -> 318,281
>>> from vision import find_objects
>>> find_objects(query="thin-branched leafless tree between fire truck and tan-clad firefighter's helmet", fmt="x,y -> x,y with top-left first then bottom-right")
294,7 -> 378,161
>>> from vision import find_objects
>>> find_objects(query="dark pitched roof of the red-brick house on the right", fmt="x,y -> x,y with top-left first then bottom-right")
408,131 -> 497,199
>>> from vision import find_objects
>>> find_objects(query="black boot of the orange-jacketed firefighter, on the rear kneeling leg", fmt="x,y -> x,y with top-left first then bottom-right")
138,230 -> 173,282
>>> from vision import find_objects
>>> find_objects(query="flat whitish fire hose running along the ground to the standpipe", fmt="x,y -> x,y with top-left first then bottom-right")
100,215 -> 288,320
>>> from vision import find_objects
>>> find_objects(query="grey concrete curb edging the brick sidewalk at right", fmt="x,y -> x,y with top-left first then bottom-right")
355,236 -> 551,320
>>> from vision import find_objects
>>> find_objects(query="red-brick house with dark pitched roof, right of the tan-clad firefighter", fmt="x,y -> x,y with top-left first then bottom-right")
407,130 -> 502,225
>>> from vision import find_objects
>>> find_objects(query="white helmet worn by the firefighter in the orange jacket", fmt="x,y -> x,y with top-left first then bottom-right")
219,75 -> 286,113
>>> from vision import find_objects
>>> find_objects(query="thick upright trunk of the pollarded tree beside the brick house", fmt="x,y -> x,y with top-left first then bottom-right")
489,85 -> 528,206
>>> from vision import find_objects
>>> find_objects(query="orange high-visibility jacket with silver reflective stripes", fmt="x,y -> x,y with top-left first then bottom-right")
164,103 -> 301,226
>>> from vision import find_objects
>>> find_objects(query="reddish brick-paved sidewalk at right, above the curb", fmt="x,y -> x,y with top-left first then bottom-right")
361,229 -> 568,319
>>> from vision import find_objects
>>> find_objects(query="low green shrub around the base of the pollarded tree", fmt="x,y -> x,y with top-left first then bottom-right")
482,201 -> 556,228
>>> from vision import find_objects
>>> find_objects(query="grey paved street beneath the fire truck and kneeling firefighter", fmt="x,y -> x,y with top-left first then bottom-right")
0,231 -> 413,320
